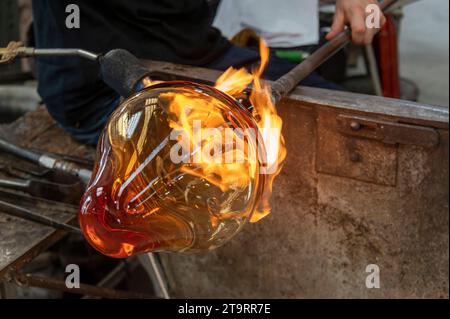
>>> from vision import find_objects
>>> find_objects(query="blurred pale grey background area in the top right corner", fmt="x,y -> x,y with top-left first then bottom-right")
399,0 -> 449,107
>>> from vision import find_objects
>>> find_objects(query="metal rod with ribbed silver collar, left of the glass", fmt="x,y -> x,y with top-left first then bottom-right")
0,139 -> 91,184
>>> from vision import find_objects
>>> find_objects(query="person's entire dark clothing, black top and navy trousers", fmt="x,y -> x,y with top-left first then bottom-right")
33,0 -> 333,144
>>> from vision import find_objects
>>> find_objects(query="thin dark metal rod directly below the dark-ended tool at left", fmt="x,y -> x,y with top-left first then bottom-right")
0,200 -> 81,234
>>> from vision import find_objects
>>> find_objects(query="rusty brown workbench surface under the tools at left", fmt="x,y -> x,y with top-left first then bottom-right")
0,107 -> 92,280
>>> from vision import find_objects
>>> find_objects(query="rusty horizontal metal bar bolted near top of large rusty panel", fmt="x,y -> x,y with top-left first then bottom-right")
337,114 -> 439,147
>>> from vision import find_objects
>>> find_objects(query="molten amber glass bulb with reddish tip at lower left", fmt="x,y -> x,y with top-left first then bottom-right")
79,82 -> 264,258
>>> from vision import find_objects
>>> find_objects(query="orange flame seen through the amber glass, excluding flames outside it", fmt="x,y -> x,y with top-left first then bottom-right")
165,89 -> 256,194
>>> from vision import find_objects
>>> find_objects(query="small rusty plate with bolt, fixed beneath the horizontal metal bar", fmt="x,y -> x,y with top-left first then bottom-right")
316,111 -> 397,186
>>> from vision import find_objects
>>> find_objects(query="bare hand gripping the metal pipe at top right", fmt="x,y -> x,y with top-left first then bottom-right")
326,0 -> 386,44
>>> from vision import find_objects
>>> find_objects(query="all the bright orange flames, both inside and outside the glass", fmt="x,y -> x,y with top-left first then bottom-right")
144,40 -> 286,222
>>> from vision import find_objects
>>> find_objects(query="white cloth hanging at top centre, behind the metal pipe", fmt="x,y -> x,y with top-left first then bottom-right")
213,0 -> 319,47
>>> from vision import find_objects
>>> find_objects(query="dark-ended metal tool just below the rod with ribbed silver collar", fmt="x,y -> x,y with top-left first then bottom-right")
0,177 -> 84,204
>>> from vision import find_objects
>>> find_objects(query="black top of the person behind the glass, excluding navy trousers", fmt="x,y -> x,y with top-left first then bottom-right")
33,0 -> 230,65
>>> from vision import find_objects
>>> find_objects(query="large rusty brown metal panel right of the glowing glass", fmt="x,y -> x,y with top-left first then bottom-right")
157,99 -> 449,298
